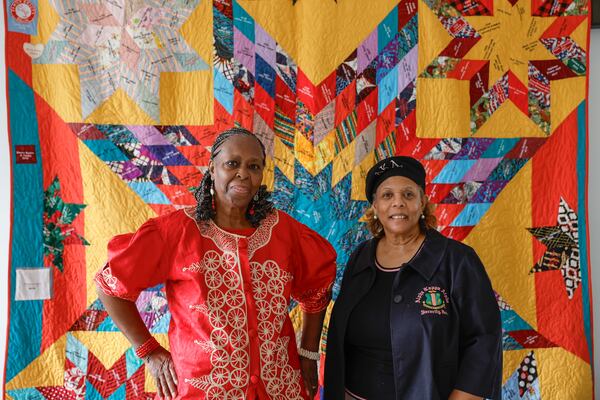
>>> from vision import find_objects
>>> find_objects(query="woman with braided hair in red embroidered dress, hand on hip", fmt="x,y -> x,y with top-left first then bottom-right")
96,128 -> 336,400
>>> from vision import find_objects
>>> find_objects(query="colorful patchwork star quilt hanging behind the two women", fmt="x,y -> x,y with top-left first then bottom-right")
4,0 -> 593,400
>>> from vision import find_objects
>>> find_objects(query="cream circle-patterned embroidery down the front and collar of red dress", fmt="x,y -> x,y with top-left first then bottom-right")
183,212 -> 302,400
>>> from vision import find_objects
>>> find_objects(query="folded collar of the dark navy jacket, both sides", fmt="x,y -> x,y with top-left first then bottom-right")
352,229 -> 448,280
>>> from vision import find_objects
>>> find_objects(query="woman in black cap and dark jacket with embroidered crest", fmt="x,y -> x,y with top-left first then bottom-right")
324,156 -> 502,400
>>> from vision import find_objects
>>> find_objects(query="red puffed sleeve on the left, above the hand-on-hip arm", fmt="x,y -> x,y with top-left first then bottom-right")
95,219 -> 168,301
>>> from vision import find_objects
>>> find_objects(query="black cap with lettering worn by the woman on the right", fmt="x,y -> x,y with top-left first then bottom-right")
365,156 -> 425,203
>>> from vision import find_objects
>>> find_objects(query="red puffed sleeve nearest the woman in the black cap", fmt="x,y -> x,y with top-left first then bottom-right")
291,223 -> 337,313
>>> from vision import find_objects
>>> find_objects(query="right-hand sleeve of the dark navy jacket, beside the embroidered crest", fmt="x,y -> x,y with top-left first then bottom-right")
455,248 -> 502,399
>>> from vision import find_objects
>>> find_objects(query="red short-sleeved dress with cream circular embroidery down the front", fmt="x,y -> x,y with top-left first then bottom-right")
96,209 -> 336,400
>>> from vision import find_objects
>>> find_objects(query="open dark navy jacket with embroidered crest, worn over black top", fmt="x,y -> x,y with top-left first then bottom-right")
324,230 -> 502,400
